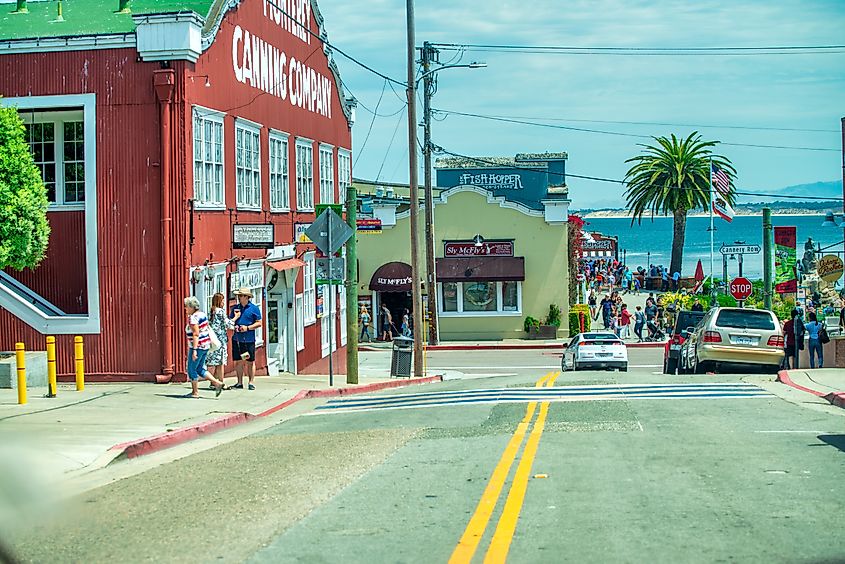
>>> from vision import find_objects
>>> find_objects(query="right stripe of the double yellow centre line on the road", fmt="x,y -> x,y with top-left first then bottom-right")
484,372 -> 560,564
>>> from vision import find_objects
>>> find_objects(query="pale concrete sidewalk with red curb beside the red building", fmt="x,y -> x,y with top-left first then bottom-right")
0,375 -> 441,480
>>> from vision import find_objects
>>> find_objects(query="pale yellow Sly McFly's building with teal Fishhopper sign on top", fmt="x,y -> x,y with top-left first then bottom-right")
357,153 -> 569,340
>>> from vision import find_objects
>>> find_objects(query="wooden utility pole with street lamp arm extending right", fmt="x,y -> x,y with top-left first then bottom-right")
416,41 -> 487,345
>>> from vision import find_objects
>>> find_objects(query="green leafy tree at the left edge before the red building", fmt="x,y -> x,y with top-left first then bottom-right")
0,108 -> 50,270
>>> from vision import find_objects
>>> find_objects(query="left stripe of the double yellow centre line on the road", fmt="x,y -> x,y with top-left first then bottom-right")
449,372 -> 556,564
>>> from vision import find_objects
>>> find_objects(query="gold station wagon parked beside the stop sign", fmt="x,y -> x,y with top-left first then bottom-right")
679,307 -> 784,374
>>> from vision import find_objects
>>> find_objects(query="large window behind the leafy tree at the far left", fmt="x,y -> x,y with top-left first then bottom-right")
19,110 -> 85,209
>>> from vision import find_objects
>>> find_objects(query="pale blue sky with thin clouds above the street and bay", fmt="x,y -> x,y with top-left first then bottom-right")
320,0 -> 845,208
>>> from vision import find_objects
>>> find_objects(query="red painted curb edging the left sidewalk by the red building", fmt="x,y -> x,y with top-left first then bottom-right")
109,376 -> 443,460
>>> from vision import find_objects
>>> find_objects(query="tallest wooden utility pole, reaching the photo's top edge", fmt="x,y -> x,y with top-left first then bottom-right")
405,0 -> 423,376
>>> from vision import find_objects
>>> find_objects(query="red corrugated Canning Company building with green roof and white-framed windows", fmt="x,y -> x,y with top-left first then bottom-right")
0,0 -> 354,381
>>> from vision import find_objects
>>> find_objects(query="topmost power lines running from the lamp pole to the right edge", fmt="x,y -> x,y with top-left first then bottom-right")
432,43 -> 845,56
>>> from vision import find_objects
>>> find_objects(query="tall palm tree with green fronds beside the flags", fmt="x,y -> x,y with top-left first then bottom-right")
625,131 -> 736,282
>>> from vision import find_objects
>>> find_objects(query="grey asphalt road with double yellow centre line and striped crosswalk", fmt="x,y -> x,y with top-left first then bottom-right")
12,349 -> 845,563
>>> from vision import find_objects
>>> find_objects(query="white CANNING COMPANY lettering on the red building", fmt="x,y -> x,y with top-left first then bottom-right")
232,17 -> 333,118
